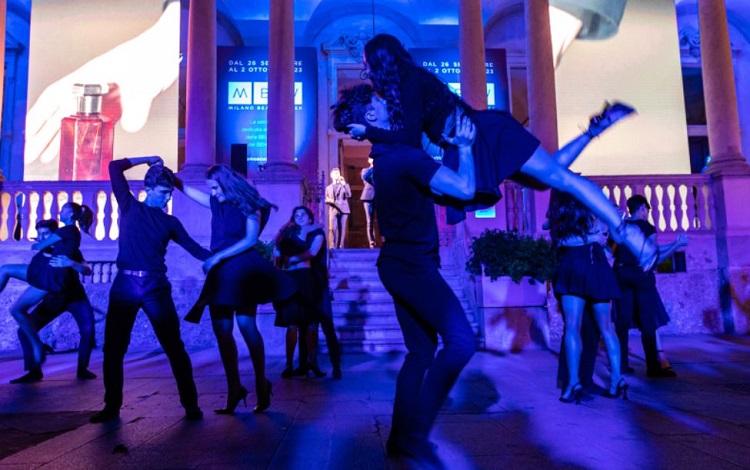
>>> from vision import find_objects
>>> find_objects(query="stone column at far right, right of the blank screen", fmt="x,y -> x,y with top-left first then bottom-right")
698,0 -> 750,174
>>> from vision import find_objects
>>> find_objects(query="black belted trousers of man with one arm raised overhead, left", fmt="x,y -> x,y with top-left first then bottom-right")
104,273 -> 198,410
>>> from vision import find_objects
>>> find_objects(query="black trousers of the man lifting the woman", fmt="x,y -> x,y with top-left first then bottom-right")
378,258 -> 476,446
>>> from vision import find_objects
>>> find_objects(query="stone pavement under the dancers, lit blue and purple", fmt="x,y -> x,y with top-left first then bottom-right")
0,336 -> 750,470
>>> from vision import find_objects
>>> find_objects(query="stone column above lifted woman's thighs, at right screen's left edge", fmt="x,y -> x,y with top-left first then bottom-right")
524,0 -> 558,234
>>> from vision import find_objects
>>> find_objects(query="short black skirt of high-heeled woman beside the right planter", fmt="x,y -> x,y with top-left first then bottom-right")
552,243 -> 620,303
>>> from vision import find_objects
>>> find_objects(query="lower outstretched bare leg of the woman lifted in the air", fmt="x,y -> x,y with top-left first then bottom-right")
521,146 -> 658,269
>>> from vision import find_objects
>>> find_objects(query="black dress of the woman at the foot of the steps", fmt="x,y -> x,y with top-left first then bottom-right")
275,228 -> 331,327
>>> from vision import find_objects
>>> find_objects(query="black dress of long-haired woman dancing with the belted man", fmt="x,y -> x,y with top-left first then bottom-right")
185,197 -> 295,323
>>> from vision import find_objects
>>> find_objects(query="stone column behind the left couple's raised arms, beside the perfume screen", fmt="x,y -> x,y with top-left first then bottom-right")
178,0 -> 216,242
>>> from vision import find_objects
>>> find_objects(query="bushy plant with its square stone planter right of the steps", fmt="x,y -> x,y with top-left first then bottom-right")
466,229 -> 556,352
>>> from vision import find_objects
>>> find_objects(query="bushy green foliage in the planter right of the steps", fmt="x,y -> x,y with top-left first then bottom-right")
466,229 -> 557,283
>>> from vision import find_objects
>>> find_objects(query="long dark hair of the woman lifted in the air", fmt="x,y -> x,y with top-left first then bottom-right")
365,34 -> 418,130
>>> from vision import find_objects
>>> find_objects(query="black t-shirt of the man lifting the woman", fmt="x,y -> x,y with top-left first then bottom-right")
370,144 -> 440,261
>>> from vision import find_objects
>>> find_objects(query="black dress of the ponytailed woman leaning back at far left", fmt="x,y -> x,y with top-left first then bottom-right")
26,224 -> 83,293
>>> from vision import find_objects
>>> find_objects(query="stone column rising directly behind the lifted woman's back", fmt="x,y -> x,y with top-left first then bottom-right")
458,0 -> 487,109
